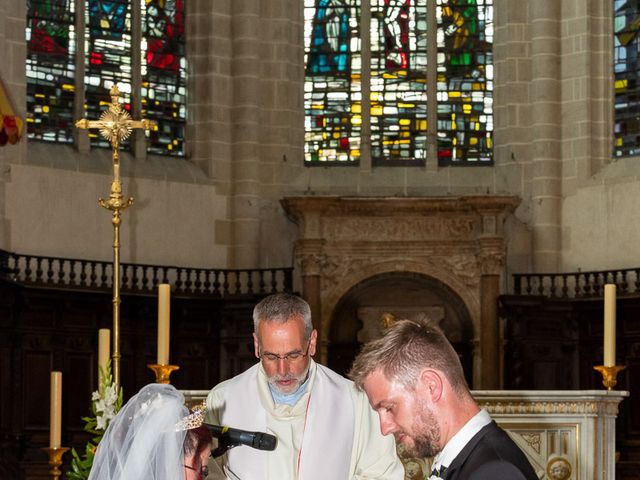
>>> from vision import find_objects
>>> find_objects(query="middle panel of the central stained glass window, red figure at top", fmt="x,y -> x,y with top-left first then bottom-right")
370,0 -> 427,164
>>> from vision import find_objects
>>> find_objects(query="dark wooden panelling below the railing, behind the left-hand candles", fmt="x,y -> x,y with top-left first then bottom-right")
0,279 -> 259,479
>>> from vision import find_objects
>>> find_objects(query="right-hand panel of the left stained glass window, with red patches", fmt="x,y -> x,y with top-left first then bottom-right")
142,0 -> 187,155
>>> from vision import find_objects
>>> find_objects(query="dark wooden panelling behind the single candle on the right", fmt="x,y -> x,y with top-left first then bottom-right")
500,295 -> 640,479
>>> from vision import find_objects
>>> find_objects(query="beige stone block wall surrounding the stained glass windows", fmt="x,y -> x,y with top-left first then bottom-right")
0,0 -> 640,276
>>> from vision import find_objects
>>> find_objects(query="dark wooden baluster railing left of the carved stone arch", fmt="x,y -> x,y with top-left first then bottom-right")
0,250 -> 293,297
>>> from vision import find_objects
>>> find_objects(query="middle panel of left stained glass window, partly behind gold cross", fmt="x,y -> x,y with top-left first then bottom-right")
85,0 -> 131,147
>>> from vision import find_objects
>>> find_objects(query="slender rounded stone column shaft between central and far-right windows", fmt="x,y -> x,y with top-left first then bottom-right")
529,0 -> 562,272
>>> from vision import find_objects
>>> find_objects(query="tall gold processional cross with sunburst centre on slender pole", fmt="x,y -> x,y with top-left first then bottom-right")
76,85 -> 154,388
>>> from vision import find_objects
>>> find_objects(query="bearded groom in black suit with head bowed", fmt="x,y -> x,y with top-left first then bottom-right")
350,320 -> 538,480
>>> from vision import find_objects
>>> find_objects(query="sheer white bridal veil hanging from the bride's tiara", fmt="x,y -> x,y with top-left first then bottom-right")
89,383 -> 189,480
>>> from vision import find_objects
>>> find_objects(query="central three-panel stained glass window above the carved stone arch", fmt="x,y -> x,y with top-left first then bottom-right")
305,0 -> 493,165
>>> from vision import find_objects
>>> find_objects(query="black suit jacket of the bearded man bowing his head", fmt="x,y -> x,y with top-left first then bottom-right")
444,421 -> 538,480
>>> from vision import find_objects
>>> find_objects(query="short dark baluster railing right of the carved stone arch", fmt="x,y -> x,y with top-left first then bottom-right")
513,268 -> 640,298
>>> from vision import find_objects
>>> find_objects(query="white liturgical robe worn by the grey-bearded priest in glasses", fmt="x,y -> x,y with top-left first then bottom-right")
206,360 -> 404,480
